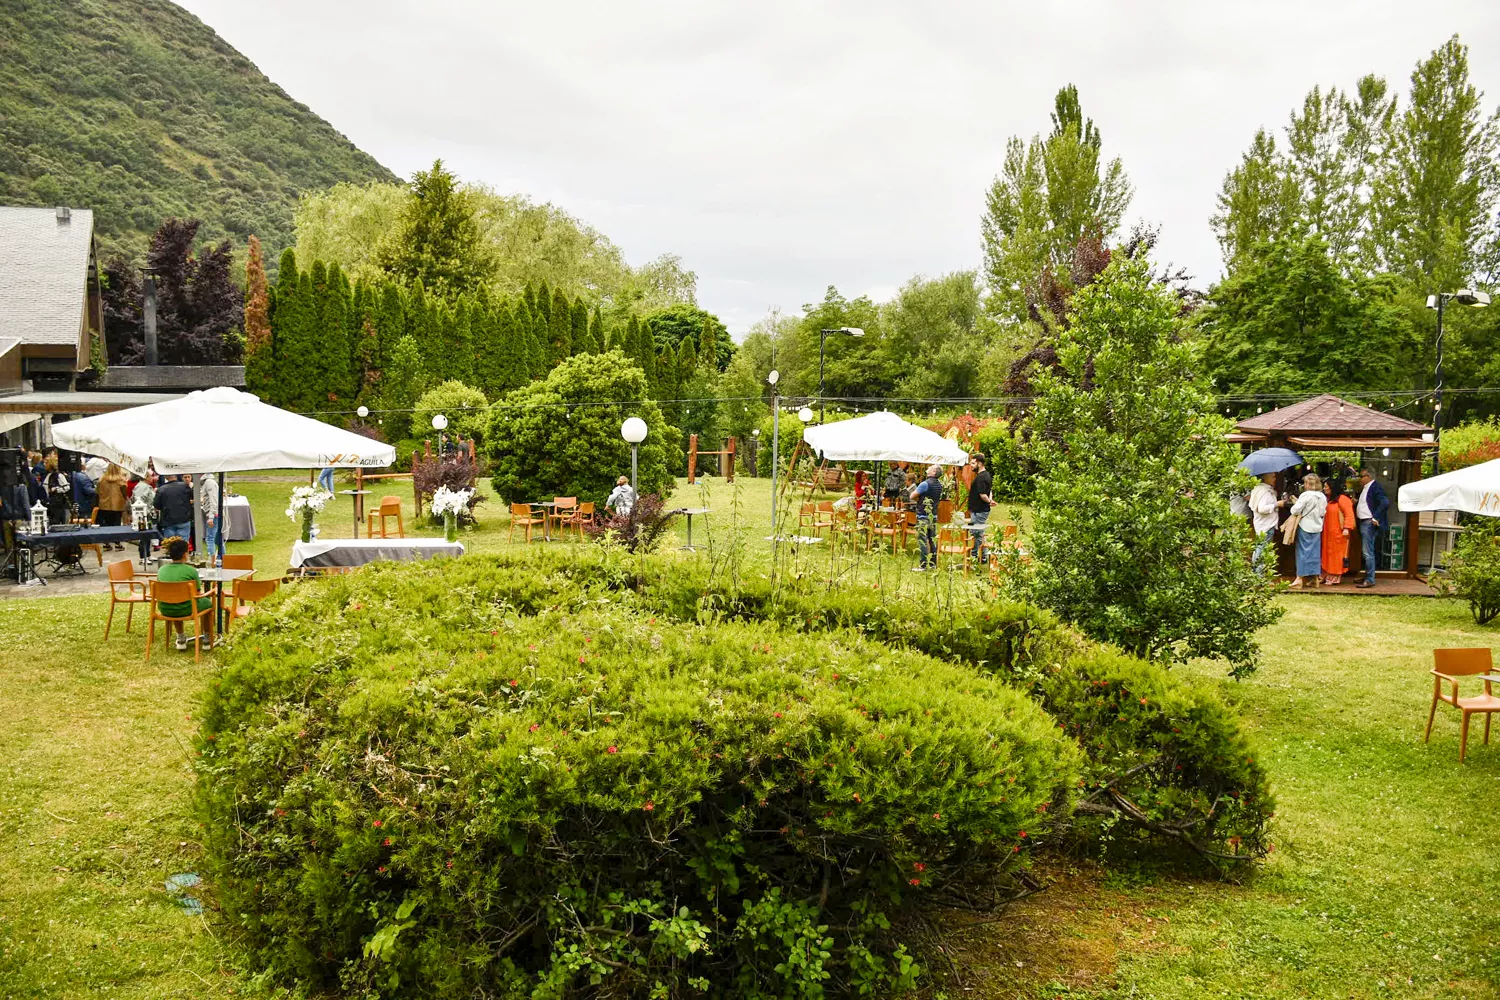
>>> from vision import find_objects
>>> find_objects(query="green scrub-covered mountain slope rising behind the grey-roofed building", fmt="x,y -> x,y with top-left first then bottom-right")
0,0 -> 395,259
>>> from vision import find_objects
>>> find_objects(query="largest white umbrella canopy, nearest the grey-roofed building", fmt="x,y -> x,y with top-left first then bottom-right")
53,388 -> 396,475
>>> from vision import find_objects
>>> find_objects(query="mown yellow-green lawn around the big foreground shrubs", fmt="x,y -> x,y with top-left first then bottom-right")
0,491 -> 1500,1000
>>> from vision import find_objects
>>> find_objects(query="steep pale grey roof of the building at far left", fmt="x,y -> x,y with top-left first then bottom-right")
0,205 -> 93,346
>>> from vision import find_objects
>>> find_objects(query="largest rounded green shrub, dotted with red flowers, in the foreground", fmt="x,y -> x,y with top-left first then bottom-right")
197,558 -> 1079,997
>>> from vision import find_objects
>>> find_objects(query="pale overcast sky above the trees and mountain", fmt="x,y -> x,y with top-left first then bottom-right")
179,0 -> 1500,334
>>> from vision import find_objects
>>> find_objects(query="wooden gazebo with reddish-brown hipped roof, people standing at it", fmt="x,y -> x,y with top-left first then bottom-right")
1230,393 -> 1434,577
